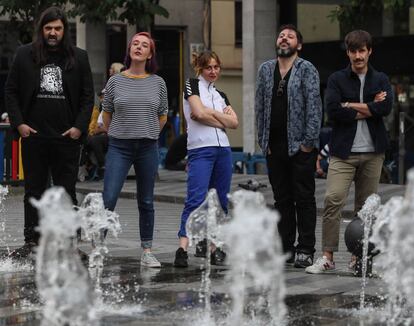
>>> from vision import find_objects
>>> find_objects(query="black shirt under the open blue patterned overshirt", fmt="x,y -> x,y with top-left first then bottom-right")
269,64 -> 292,148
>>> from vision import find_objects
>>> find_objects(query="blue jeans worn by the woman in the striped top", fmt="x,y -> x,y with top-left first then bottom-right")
103,137 -> 158,249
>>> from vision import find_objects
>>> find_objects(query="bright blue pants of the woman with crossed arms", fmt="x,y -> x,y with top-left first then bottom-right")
178,147 -> 232,237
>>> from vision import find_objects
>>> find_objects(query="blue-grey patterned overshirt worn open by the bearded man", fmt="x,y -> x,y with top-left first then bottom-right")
255,57 -> 322,156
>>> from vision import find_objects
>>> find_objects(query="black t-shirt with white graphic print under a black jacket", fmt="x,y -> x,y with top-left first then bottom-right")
27,51 -> 75,139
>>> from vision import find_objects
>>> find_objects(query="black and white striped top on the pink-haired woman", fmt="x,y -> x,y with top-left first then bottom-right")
102,73 -> 168,139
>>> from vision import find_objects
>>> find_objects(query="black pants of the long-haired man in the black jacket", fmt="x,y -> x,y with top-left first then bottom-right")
22,137 -> 80,243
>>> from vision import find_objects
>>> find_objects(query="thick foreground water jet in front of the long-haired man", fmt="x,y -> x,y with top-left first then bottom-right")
31,187 -> 94,326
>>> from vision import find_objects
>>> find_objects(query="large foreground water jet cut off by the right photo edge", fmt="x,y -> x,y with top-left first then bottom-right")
371,170 -> 414,325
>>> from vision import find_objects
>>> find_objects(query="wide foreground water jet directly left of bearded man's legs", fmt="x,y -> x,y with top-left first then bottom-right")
220,190 -> 287,326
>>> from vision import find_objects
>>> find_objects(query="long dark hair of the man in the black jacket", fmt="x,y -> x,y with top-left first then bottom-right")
32,7 -> 75,70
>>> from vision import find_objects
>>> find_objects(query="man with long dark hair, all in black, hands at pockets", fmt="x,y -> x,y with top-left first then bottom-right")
5,7 -> 94,258
